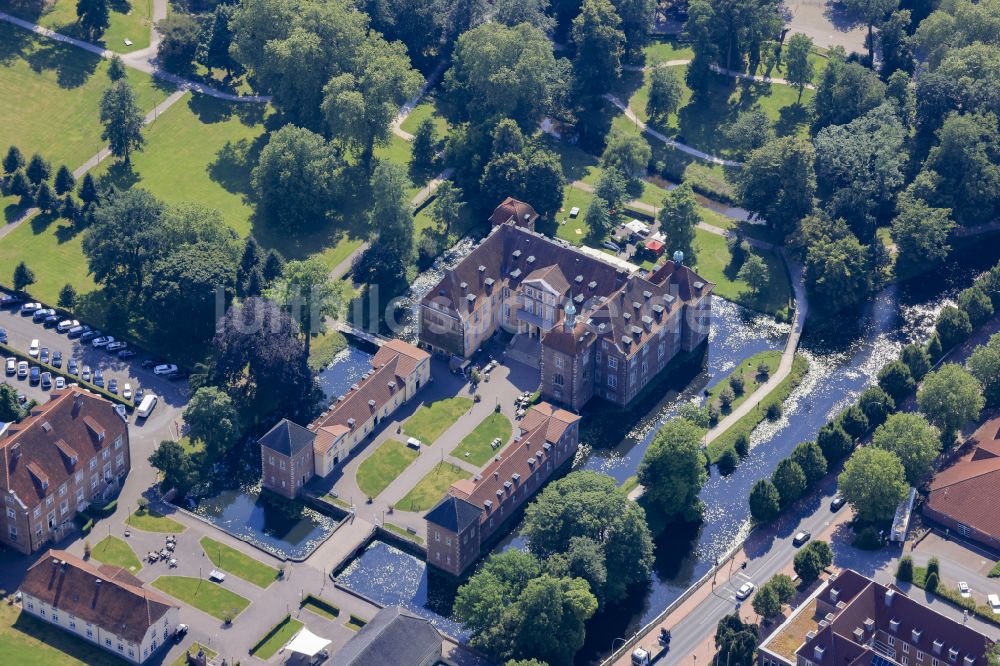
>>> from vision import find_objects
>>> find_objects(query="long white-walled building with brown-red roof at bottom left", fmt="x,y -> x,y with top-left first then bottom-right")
20,550 -> 180,664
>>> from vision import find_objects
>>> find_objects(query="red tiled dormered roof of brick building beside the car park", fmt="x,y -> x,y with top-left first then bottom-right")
0,390 -> 128,508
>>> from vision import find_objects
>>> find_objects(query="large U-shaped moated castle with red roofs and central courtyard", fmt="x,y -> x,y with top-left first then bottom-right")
419,198 -> 714,410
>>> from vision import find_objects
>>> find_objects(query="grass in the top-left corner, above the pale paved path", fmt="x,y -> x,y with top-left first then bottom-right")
0,0 -> 153,53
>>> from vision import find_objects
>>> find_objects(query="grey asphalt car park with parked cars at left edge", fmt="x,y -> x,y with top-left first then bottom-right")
0,298 -> 188,438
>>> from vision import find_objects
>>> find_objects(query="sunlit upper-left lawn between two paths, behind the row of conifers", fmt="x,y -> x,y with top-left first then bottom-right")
0,21 -> 172,167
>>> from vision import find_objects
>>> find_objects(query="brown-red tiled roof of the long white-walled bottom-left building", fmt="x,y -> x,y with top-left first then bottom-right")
20,550 -> 178,643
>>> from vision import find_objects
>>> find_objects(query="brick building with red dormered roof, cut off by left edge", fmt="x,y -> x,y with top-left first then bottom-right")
0,389 -> 131,554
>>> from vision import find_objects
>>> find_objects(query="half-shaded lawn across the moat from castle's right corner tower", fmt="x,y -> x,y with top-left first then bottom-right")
695,229 -> 791,317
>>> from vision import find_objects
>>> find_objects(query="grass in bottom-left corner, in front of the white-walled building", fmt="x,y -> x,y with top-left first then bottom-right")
0,603 -> 125,666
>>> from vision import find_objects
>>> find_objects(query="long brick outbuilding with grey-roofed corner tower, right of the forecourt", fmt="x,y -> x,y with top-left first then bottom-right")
424,402 -> 580,576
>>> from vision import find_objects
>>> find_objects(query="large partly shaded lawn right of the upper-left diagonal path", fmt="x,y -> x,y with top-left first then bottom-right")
94,93 -> 267,236
